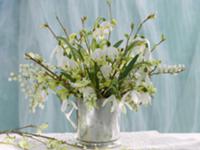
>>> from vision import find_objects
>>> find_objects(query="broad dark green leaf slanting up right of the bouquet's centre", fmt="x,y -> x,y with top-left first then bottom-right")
119,54 -> 139,80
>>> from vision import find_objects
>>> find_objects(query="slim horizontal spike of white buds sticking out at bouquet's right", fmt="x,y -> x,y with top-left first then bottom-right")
156,64 -> 185,74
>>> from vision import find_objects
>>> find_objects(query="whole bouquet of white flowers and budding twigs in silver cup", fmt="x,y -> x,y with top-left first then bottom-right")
9,2 -> 184,122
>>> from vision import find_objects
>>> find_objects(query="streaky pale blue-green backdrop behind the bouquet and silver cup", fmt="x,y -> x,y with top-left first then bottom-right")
0,0 -> 200,132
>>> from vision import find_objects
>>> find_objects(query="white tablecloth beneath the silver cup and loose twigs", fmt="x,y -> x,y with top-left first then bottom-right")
0,131 -> 200,150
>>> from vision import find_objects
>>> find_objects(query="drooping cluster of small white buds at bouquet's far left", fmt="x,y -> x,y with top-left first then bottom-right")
8,64 -> 49,112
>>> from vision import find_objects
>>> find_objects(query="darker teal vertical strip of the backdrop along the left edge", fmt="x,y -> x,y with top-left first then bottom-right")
0,0 -> 19,130
